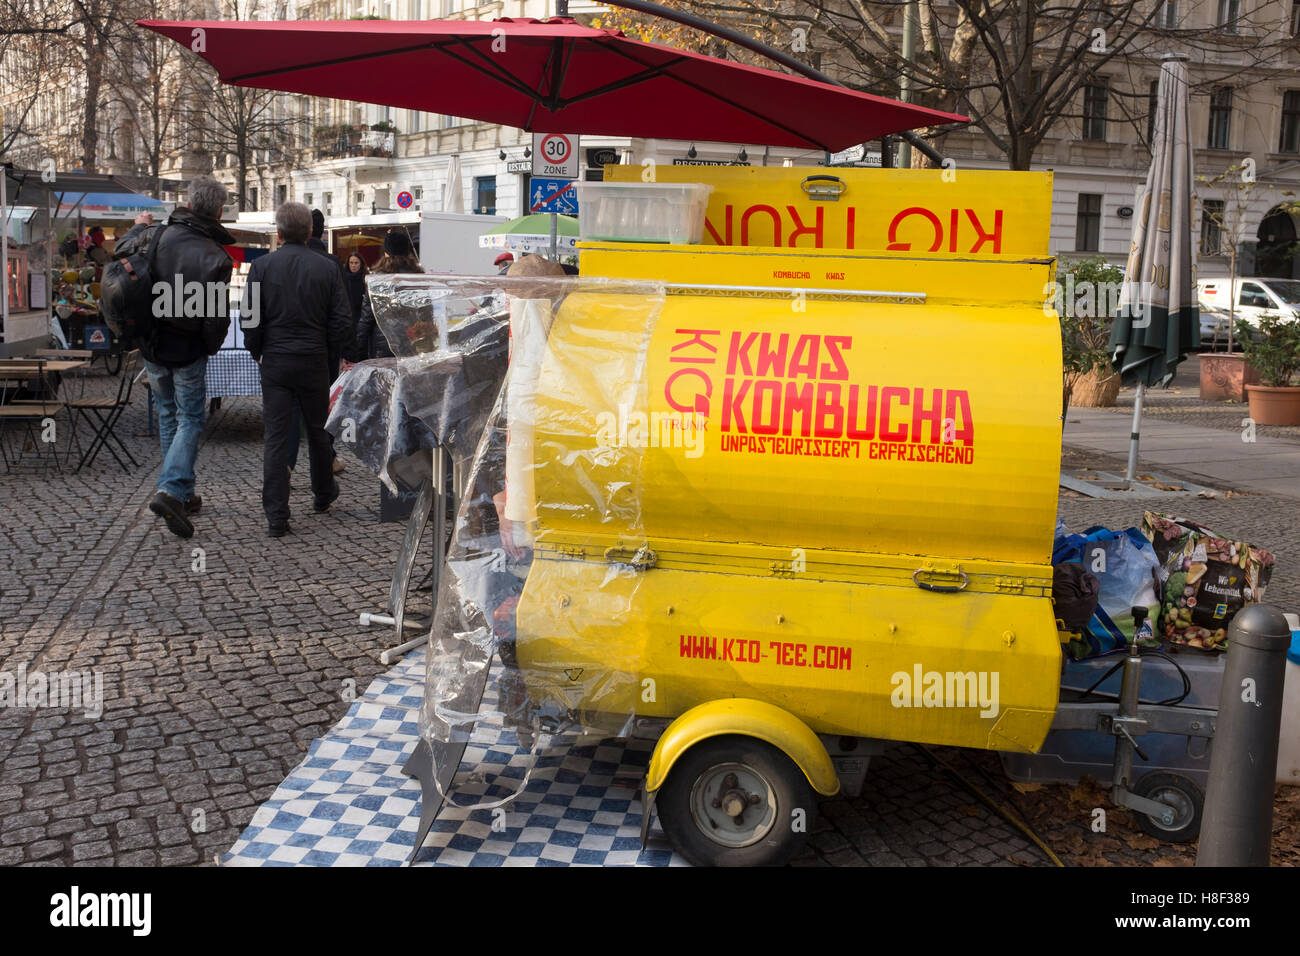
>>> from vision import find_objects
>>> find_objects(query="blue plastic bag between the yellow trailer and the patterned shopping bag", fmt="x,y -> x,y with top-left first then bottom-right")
1052,525 -> 1160,661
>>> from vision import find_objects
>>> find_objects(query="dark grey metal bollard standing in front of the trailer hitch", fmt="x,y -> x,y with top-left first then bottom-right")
1196,605 -> 1291,866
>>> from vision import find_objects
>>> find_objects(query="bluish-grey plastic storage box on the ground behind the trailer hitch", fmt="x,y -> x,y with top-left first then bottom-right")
1002,648 -> 1223,790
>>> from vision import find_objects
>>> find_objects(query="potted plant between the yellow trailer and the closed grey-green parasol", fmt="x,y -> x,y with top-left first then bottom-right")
1056,256 -> 1123,411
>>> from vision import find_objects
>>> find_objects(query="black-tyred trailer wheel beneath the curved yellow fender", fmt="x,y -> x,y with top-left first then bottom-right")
655,735 -> 816,866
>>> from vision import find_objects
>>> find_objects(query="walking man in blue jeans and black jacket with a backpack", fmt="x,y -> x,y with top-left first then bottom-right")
113,176 -> 235,537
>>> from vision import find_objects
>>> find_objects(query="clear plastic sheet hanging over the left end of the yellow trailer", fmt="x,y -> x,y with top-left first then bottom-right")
416,277 -> 664,770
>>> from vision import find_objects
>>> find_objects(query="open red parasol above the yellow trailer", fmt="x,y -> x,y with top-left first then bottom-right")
139,18 -> 967,152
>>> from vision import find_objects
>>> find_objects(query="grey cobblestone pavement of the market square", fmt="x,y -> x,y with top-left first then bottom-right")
0,369 -> 1300,866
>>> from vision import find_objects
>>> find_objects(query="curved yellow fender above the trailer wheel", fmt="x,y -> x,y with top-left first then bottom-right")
645,697 -> 840,796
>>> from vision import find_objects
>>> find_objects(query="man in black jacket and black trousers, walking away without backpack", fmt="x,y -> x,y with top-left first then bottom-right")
241,203 -> 352,537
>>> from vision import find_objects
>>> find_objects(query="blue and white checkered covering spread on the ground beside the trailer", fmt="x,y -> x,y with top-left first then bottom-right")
221,650 -> 688,866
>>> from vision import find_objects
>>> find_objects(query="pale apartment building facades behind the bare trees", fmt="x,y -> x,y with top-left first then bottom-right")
0,0 -> 1300,276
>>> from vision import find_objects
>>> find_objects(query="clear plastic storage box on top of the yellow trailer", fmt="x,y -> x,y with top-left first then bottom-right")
573,182 -> 714,245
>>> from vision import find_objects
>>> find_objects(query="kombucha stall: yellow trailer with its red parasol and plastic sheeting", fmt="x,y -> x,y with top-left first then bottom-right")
139,11 -> 1289,865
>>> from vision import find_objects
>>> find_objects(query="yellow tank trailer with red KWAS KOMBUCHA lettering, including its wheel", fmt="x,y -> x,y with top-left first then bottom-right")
506,168 -> 1061,864
